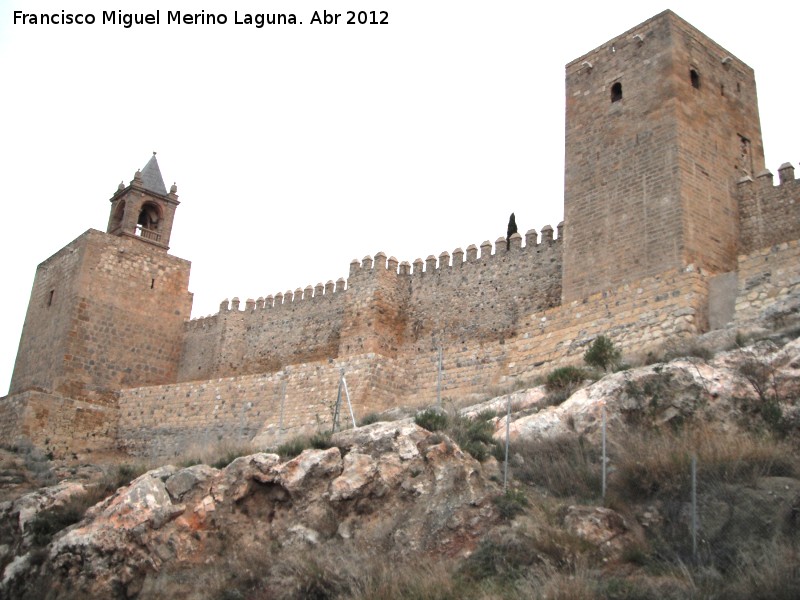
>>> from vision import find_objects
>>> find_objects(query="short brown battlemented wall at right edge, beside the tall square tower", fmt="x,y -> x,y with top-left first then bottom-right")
738,163 -> 800,254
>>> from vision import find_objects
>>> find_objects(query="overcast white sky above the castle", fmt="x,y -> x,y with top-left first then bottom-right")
0,0 -> 800,393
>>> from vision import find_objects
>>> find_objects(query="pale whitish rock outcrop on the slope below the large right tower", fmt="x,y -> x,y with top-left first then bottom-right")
495,339 -> 800,440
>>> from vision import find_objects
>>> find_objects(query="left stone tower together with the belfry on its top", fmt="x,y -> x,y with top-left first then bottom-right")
10,153 -> 192,405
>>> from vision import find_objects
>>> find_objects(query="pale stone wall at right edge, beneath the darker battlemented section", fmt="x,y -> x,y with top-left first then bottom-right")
734,240 -> 800,327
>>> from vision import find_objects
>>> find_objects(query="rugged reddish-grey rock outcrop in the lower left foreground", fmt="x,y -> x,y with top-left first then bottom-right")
0,422 -> 497,598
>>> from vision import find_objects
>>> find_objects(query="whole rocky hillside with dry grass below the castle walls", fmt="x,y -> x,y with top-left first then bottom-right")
0,333 -> 800,599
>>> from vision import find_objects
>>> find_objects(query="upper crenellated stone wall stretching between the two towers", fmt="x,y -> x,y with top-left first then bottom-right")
177,227 -> 563,381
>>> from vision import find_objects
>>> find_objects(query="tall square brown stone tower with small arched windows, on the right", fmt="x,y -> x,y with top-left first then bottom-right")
563,11 -> 764,302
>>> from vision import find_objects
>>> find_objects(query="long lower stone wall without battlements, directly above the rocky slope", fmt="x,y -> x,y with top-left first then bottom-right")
119,264 -> 706,457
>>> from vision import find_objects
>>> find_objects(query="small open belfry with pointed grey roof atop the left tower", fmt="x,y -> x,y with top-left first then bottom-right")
106,152 -> 180,250
